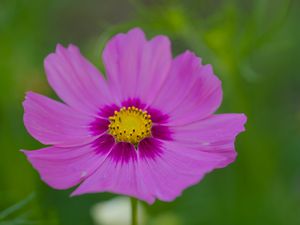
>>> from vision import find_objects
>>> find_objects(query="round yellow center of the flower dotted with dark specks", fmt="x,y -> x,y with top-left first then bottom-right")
108,106 -> 152,145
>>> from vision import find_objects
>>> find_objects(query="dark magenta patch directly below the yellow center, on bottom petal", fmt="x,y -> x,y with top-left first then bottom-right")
109,142 -> 137,163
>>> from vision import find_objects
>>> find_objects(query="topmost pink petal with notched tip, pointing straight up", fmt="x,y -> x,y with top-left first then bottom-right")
103,28 -> 172,103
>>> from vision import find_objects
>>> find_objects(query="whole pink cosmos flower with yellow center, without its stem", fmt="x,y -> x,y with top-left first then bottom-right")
23,28 -> 246,204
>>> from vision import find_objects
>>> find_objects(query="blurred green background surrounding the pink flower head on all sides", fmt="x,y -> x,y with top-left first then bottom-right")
0,0 -> 300,225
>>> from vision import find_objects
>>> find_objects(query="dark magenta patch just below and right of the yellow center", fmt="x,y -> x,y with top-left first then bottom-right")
138,138 -> 163,159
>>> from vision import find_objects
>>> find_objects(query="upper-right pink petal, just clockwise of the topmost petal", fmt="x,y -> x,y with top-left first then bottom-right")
152,51 -> 222,125
